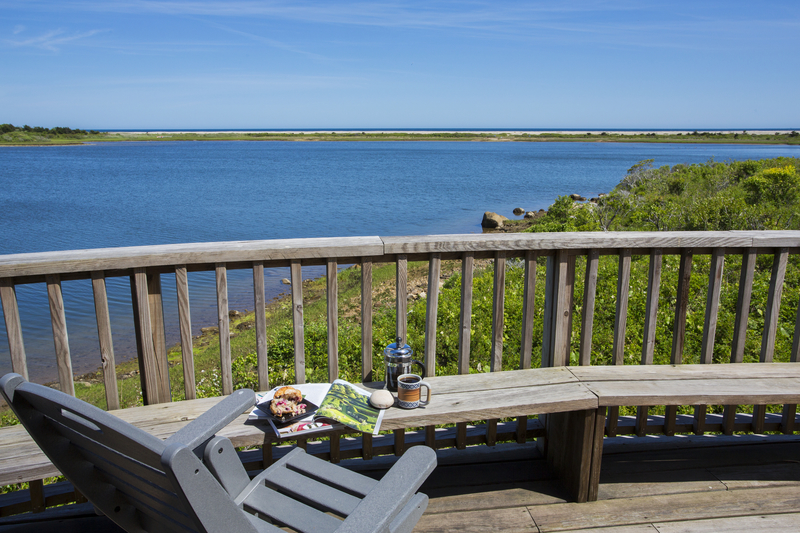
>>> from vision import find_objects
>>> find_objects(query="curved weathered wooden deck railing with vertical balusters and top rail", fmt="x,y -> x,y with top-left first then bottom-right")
0,231 -> 800,512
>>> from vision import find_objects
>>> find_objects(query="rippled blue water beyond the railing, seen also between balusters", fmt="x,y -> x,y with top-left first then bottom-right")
0,141 -> 800,380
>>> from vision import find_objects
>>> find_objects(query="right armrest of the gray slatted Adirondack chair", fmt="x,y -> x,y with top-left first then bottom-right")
336,446 -> 436,533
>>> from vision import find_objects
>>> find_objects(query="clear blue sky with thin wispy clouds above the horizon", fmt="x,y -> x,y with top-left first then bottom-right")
0,0 -> 800,129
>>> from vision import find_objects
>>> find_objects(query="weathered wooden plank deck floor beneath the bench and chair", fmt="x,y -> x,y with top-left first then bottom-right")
0,435 -> 800,533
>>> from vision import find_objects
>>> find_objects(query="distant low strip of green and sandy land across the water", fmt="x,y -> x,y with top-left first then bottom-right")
0,124 -> 800,145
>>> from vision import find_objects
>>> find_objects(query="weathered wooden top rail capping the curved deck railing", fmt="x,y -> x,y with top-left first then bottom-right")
0,231 -> 800,278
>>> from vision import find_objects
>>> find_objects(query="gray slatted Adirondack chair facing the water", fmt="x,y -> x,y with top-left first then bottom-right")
0,373 -> 436,533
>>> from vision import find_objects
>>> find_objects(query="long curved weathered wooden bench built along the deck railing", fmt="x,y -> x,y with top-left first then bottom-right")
0,363 -> 800,512
